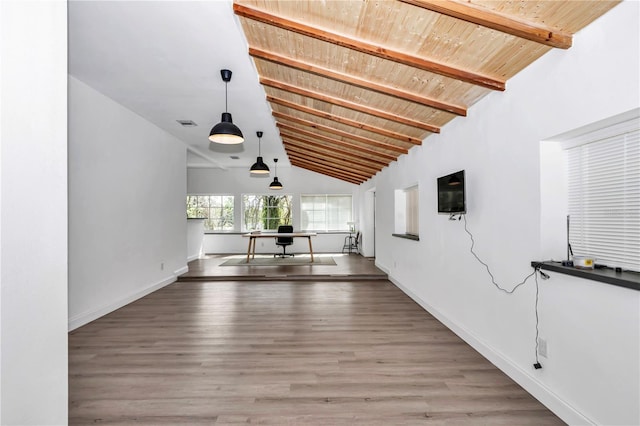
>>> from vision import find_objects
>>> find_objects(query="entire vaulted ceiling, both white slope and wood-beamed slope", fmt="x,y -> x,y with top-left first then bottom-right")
68,0 -> 618,184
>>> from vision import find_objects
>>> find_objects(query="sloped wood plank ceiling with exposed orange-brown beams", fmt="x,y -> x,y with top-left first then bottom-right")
234,0 -> 619,184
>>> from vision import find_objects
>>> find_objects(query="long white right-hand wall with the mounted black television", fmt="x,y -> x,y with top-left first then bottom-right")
359,1 -> 640,425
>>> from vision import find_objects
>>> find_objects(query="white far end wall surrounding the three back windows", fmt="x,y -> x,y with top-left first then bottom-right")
187,166 -> 358,253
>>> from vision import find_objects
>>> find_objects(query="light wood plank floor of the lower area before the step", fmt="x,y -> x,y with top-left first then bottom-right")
69,255 -> 563,425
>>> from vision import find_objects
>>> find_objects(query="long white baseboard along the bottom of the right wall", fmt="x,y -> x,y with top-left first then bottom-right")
376,270 -> 596,425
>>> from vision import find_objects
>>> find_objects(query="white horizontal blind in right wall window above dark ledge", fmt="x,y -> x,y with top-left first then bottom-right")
567,127 -> 640,271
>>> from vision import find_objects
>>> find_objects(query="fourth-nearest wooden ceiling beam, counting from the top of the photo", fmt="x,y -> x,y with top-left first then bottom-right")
260,77 -> 440,133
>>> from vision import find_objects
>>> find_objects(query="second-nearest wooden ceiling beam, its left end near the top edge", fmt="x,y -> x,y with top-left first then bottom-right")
233,3 -> 506,90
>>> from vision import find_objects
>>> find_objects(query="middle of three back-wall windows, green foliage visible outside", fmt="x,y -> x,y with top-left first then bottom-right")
242,194 -> 292,231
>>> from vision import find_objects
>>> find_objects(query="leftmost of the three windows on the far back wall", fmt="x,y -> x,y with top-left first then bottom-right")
187,195 -> 233,231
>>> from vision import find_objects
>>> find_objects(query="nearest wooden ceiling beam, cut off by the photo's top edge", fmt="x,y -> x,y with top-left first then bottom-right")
400,0 -> 573,49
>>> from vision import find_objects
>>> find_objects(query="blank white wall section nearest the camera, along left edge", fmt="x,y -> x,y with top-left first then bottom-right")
0,1 -> 67,425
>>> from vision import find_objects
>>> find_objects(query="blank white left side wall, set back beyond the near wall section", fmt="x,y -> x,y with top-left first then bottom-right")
69,76 -> 187,329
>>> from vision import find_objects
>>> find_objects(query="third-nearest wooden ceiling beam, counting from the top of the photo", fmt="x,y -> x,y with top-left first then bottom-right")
249,47 -> 467,116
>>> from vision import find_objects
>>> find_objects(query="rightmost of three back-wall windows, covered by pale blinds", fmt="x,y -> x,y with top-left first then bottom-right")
300,194 -> 353,232
